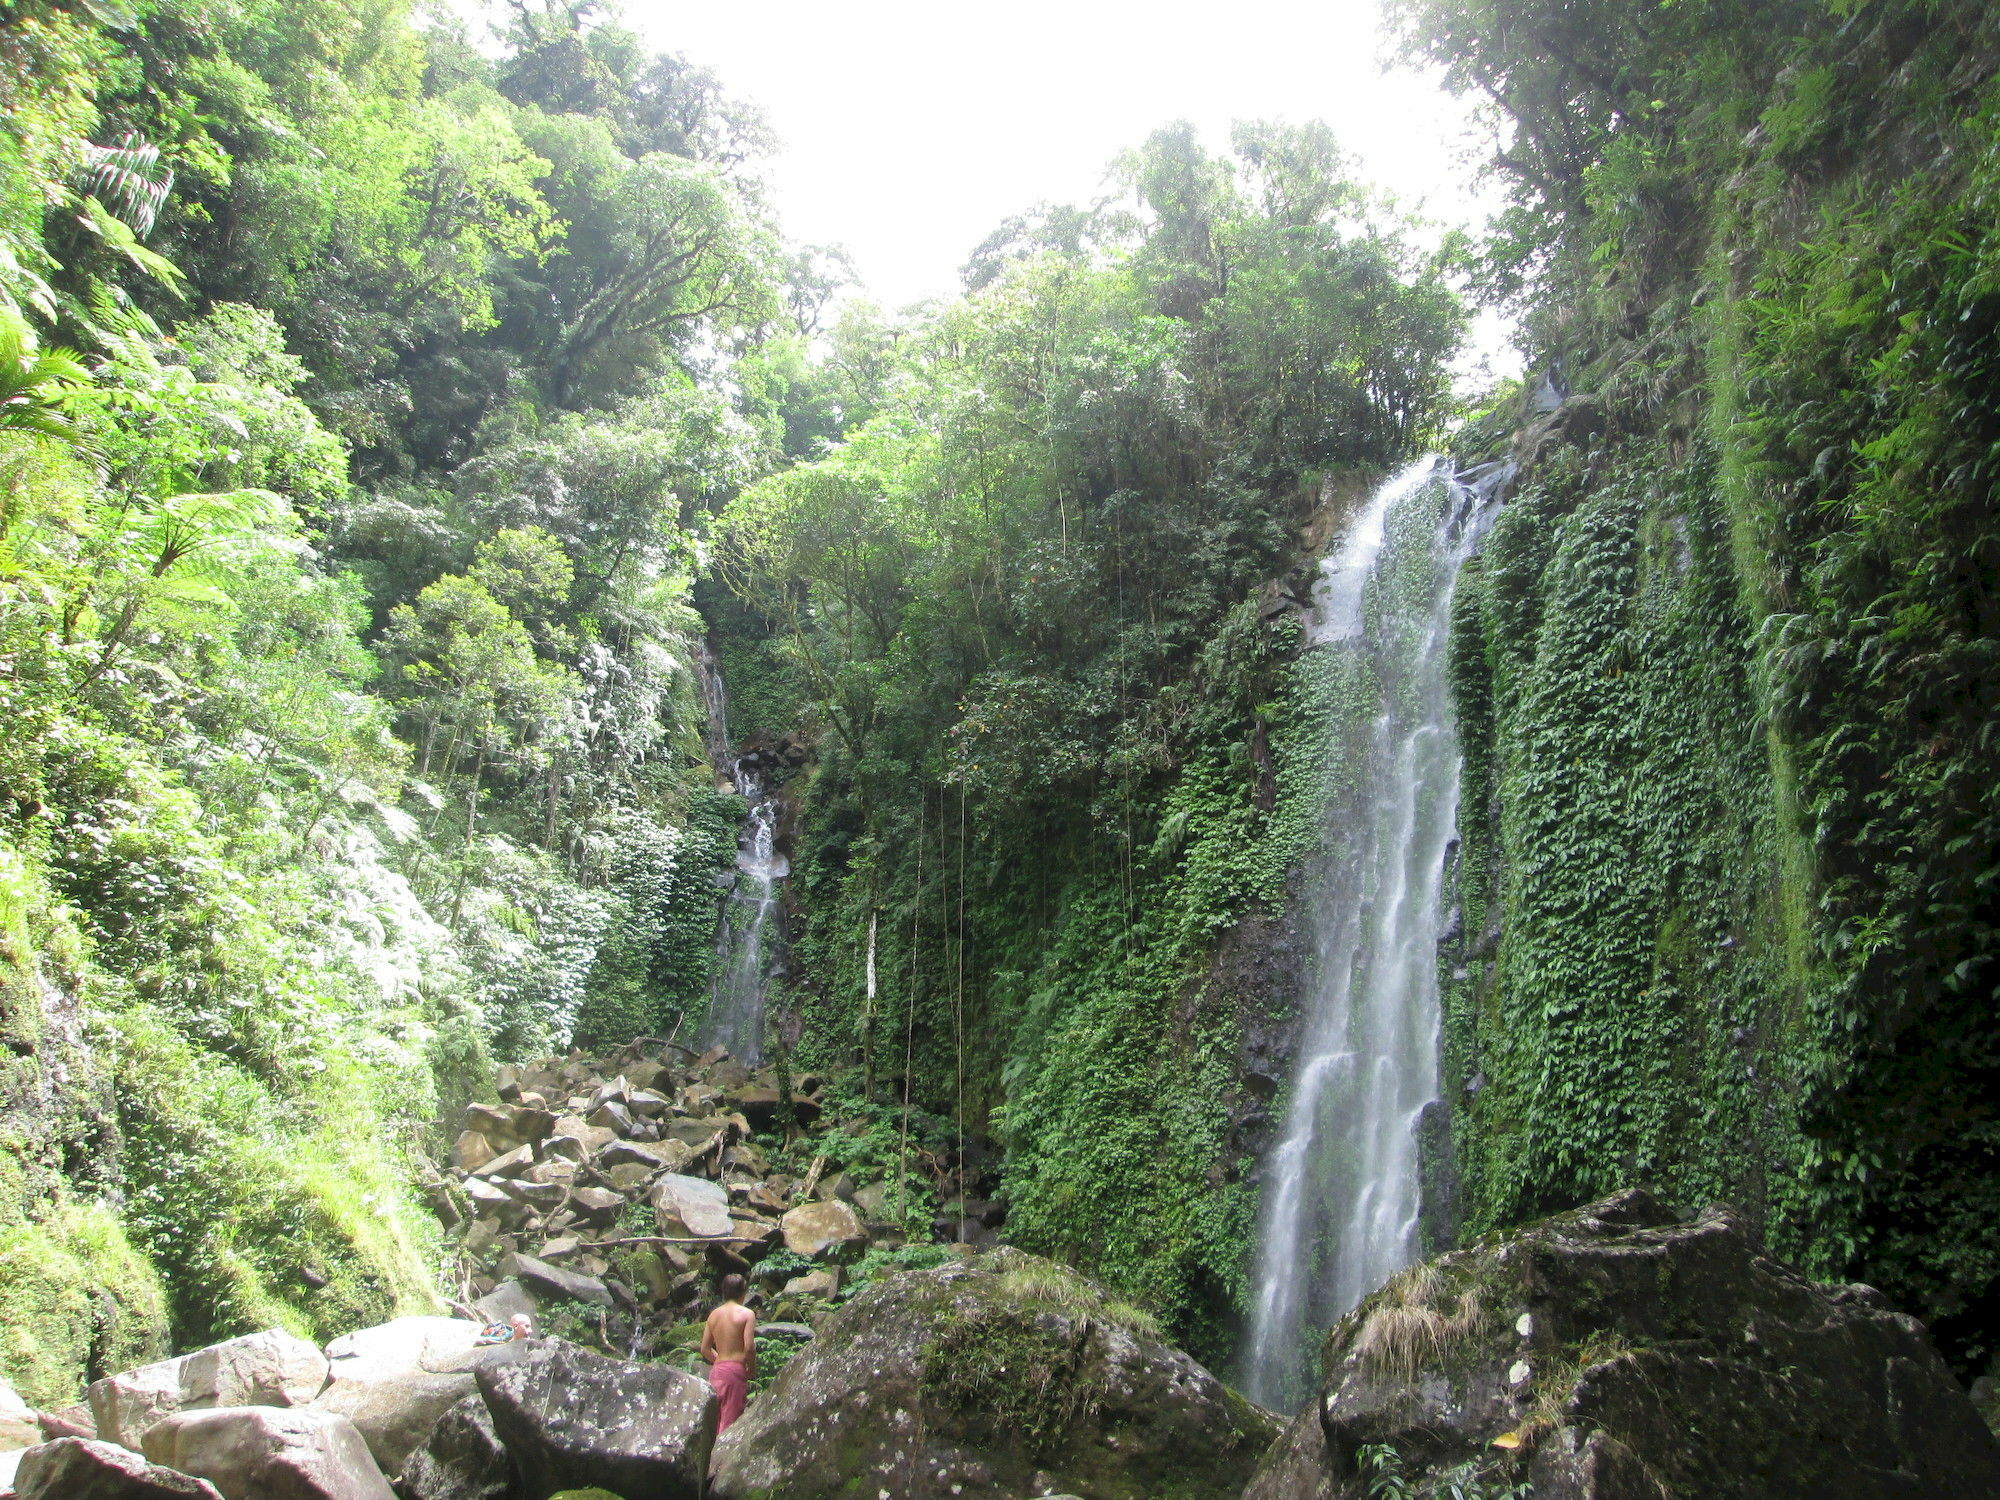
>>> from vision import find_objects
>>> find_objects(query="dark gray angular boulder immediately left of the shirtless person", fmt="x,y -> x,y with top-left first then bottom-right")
478,1340 -> 716,1500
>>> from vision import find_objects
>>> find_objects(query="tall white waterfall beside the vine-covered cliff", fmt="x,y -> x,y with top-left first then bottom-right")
1244,458 -> 1504,1410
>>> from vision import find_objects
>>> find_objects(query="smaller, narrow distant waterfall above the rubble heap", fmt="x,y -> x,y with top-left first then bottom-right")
696,642 -> 792,1066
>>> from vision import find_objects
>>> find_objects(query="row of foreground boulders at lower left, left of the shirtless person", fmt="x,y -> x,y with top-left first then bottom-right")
0,1318 -> 716,1500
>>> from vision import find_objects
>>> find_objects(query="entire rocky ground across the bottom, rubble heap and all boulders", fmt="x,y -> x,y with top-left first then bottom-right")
0,1042 -> 2000,1500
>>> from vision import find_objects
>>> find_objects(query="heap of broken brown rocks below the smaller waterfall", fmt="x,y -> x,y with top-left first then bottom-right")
432,1040 -> 1002,1354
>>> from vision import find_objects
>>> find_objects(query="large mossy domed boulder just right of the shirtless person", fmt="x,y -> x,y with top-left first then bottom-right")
710,1250 -> 1278,1500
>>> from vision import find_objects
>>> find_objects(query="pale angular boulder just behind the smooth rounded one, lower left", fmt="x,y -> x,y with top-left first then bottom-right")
88,1328 -> 326,1448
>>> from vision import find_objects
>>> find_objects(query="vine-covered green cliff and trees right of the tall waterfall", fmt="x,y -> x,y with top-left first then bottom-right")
1402,0 -> 2000,1372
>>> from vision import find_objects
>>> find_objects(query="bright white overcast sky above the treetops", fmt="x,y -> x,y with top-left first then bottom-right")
476,0 -> 1504,376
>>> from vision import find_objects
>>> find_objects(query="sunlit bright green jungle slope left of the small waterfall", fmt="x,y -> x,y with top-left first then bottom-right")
0,0 -> 824,1406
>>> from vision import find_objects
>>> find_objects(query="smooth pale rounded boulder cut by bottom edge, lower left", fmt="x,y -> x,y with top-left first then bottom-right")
146,1406 -> 396,1500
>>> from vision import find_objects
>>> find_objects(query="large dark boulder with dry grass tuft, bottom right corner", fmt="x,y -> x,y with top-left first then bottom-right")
1244,1192 -> 2000,1500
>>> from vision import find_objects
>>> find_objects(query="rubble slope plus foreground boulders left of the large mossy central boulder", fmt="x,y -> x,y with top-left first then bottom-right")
0,1038 -> 1048,1500
